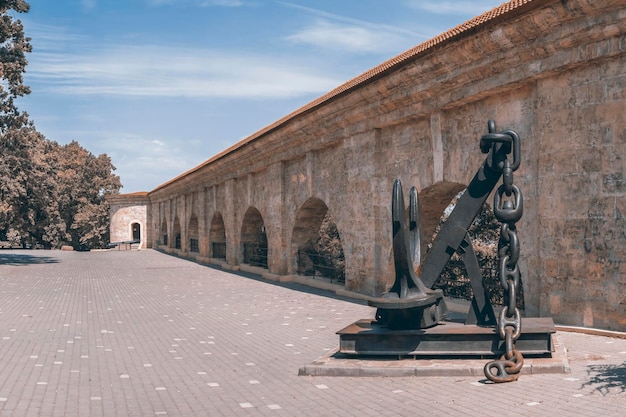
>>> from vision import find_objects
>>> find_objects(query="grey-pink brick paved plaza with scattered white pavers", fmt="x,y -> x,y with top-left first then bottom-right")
0,250 -> 626,417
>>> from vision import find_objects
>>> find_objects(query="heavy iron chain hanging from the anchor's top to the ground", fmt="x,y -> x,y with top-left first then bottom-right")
480,120 -> 524,383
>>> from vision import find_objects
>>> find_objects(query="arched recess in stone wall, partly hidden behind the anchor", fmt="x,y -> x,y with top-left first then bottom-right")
419,182 -> 524,308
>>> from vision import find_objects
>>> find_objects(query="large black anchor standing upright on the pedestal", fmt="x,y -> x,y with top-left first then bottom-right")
369,120 -> 521,329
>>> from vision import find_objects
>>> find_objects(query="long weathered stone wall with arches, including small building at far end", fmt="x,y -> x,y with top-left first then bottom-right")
110,0 -> 626,330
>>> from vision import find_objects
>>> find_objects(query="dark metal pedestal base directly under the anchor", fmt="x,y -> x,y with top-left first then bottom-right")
337,317 -> 556,357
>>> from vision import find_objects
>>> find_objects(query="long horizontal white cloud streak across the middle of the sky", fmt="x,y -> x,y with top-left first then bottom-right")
28,45 -> 341,98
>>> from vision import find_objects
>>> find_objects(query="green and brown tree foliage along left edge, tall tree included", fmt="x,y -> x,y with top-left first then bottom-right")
0,0 -> 121,249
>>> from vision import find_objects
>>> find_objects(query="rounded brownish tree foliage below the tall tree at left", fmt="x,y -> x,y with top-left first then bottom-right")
0,127 -> 121,249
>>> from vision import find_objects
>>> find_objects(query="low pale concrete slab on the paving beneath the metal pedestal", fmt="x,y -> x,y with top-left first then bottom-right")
299,333 -> 570,377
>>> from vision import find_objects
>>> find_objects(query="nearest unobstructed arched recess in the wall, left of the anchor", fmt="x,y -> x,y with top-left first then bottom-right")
291,198 -> 345,282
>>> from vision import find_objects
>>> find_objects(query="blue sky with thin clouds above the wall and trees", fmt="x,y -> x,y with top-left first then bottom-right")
18,0 -> 503,193
